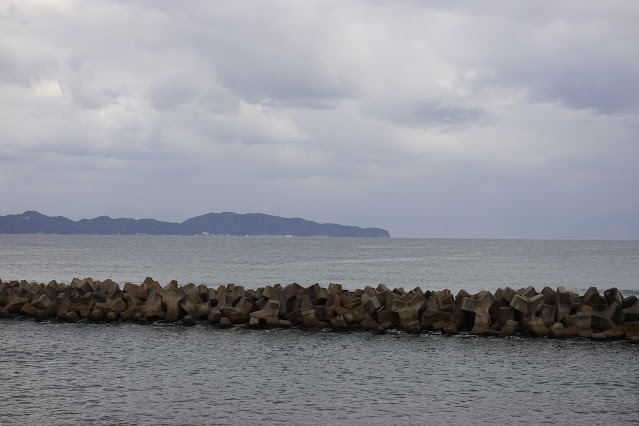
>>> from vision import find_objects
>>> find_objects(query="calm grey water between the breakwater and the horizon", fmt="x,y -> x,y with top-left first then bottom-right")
0,235 -> 639,295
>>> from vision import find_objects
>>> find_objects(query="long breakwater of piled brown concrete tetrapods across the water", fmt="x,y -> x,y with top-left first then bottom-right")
0,278 -> 639,343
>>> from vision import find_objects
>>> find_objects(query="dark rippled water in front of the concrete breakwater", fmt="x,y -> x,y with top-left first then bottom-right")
0,320 -> 639,425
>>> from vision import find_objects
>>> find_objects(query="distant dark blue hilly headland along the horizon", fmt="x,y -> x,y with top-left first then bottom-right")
0,211 -> 390,237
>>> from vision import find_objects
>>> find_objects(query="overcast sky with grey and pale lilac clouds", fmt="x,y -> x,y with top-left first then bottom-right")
0,0 -> 639,239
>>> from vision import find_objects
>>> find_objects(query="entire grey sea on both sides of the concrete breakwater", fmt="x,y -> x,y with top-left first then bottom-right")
0,235 -> 639,425
